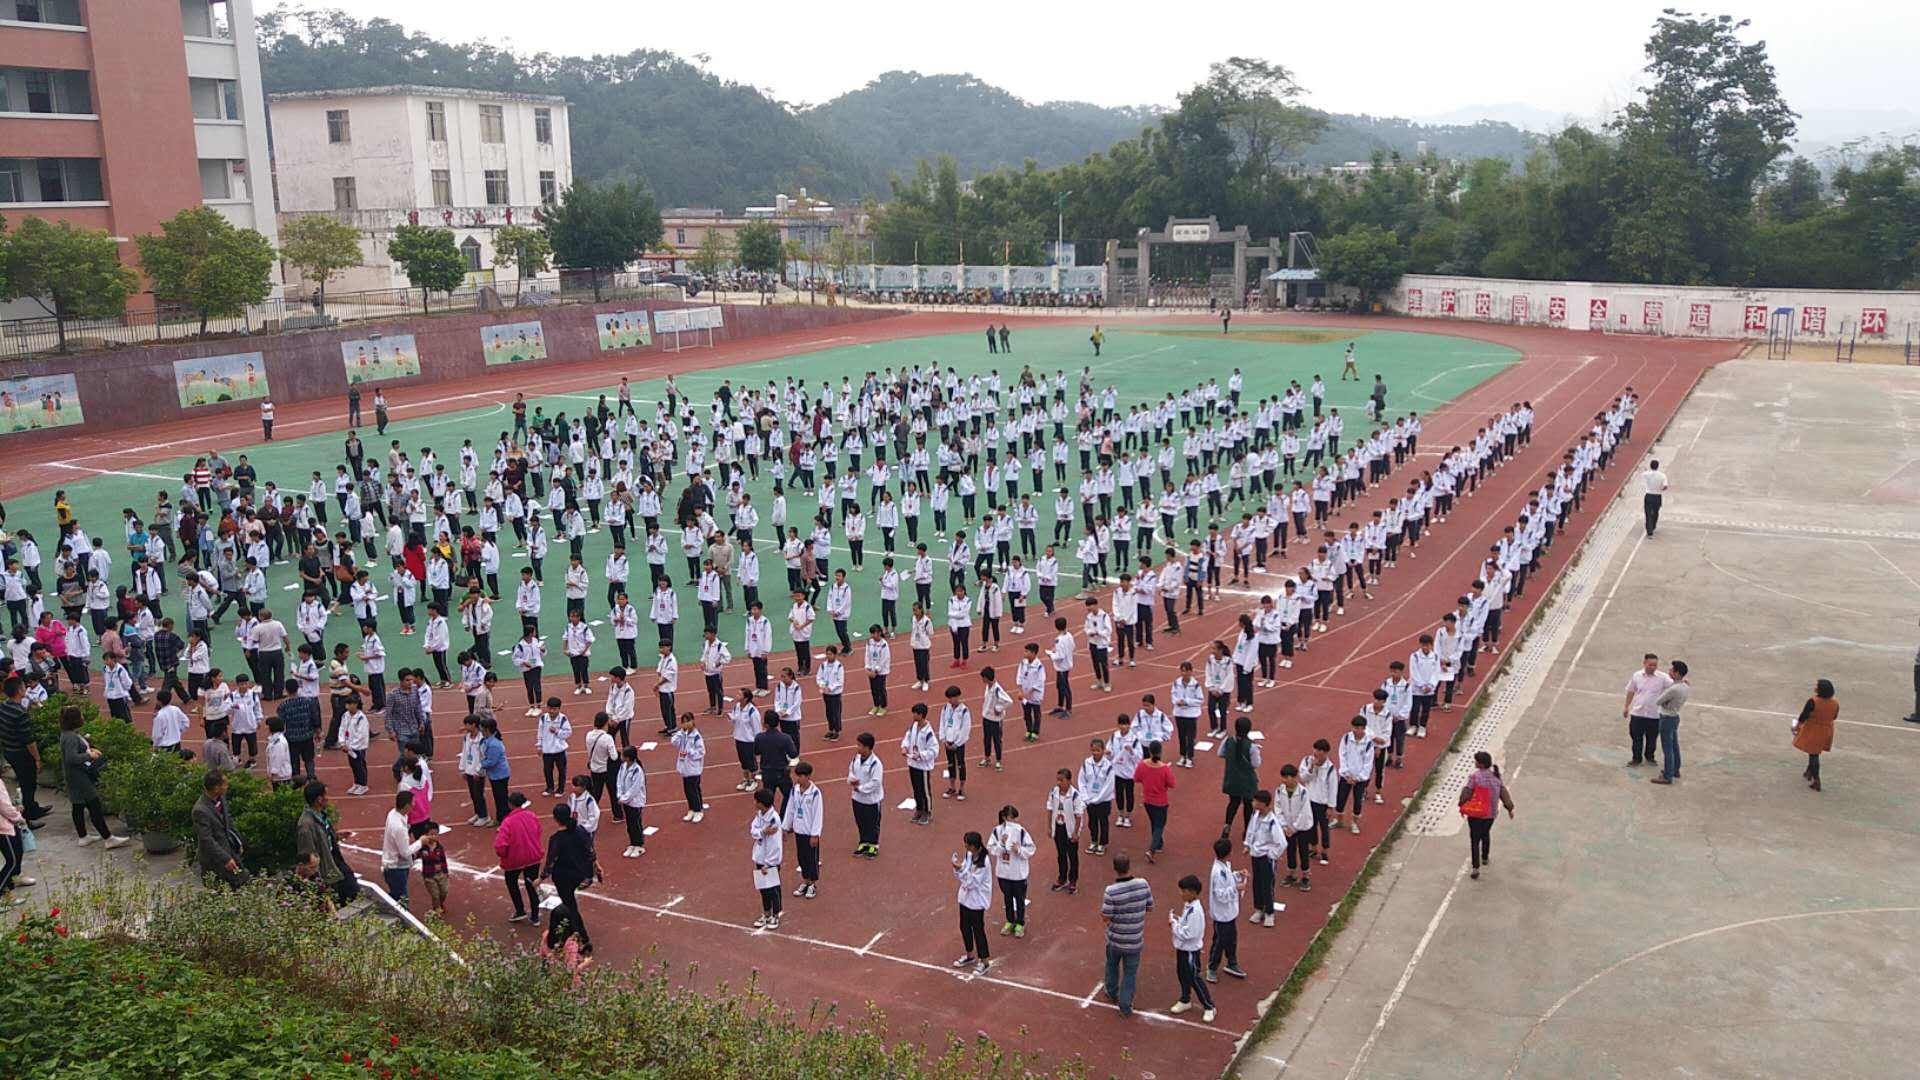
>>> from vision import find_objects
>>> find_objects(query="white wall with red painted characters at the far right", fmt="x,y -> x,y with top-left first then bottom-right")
1386,275 -> 1920,344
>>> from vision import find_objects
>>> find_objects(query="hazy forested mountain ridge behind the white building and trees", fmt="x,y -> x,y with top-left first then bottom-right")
261,12 -> 1534,208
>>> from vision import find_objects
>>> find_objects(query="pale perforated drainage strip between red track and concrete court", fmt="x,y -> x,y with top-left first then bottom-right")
1407,500 -> 1638,836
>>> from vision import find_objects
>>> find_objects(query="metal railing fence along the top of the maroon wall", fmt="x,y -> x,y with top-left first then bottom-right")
0,273 -> 685,359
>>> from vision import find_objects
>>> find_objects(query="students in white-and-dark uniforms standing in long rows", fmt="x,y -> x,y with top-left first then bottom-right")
6,334 -> 1632,1006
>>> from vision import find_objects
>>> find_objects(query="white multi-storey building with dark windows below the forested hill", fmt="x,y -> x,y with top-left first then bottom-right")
271,86 -> 574,292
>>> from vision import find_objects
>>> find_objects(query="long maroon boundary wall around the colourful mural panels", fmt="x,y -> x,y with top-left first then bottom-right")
0,300 -> 899,446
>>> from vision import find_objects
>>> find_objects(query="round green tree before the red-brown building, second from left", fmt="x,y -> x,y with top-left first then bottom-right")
134,206 -> 275,334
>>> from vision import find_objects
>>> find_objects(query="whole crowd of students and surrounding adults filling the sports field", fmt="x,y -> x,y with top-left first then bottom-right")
0,343 -> 1638,1019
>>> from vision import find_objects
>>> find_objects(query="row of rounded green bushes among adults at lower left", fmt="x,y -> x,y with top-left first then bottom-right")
33,694 -> 305,871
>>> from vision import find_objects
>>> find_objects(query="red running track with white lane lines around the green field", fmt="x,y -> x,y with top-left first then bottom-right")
13,315 -> 1732,1076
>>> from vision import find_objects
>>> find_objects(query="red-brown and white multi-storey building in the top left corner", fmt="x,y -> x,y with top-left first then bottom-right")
0,0 -> 278,317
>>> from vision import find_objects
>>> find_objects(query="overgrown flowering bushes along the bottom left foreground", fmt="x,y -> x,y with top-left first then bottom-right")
33,868 -> 1079,1080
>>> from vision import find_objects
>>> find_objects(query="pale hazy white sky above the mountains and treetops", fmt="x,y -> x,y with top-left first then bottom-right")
274,0 -> 1920,115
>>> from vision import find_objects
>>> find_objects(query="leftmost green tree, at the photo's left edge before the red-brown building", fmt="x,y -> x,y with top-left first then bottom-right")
0,217 -> 140,350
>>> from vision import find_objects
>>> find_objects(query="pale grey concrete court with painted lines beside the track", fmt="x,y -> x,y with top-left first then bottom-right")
1240,359 -> 1920,1080
